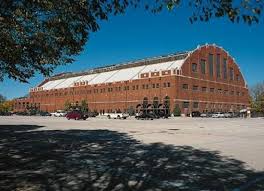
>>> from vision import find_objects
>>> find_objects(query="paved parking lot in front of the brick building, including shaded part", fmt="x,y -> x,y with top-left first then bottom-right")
0,116 -> 264,190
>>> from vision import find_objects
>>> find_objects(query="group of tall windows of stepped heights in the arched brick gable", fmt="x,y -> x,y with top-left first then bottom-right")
192,54 -> 241,81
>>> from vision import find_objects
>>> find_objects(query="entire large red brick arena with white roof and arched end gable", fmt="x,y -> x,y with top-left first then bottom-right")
14,45 -> 249,113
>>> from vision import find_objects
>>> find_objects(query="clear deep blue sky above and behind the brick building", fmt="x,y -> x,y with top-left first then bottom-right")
0,8 -> 264,99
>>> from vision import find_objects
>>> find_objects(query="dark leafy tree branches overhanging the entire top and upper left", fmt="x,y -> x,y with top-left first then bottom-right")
0,0 -> 264,82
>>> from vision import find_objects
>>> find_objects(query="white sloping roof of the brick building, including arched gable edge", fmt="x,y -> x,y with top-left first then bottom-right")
34,44 -> 245,90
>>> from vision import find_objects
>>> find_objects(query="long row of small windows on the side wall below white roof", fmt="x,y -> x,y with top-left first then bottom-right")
29,82 -> 171,98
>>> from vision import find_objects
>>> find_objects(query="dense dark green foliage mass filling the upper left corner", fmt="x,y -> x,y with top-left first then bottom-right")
0,0 -> 137,82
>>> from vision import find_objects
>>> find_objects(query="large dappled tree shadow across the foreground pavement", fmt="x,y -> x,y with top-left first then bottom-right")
0,125 -> 264,191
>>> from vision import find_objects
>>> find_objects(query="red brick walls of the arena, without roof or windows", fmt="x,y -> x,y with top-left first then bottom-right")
15,46 -> 249,113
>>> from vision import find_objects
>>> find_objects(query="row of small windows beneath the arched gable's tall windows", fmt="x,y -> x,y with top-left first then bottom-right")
182,84 -> 245,96
